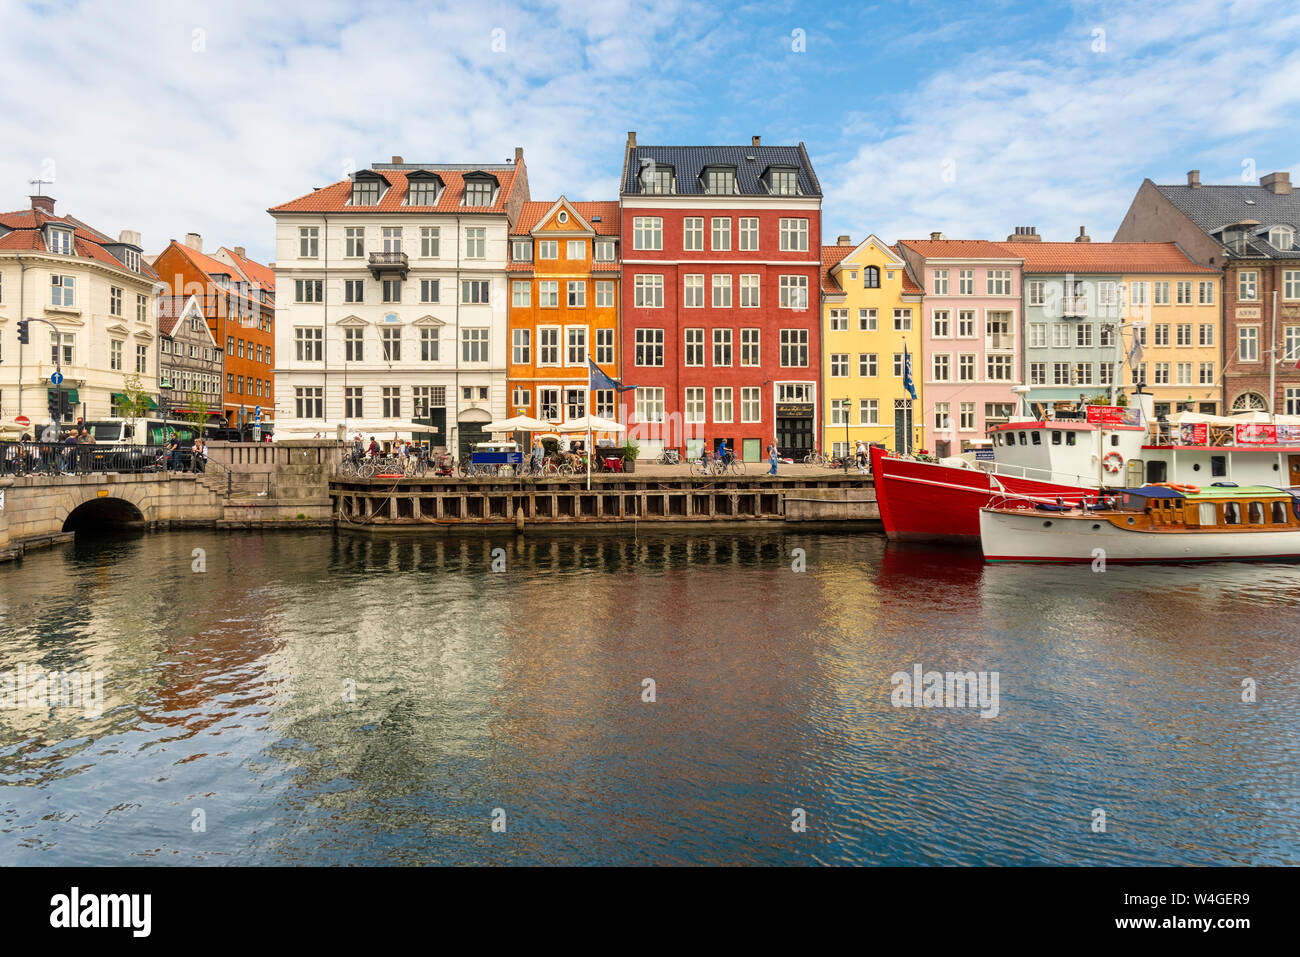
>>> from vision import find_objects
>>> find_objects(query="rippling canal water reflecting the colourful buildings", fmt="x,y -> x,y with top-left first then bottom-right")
0,527 -> 1300,865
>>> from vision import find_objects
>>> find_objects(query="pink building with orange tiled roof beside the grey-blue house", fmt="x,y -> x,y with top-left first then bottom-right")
898,233 -> 1023,456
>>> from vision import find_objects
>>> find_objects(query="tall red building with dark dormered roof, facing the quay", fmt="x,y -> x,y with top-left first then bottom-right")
620,133 -> 822,462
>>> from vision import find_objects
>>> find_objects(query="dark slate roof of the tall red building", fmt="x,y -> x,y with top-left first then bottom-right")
620,143 -> 822,196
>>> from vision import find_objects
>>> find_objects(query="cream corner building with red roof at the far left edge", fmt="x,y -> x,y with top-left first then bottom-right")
0,196 -> 159,425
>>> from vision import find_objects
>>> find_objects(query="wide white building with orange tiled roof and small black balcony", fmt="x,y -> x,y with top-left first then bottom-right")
269,148 -> 529,450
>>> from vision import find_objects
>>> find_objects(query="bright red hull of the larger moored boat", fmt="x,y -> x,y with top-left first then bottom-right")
871,449 -> 1097,546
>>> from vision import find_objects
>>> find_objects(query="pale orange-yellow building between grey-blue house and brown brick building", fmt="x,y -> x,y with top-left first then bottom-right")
1122,270 -> 1226,416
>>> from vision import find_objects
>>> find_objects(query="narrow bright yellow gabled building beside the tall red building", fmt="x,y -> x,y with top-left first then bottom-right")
822,235 -> 924,455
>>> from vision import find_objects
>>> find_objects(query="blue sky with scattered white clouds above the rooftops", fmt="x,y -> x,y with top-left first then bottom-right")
0,0 -> 1300,259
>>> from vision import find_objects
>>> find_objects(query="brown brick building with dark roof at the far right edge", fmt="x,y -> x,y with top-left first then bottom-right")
1115,169 -> 1300,415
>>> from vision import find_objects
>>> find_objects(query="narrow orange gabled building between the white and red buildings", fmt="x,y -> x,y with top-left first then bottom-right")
507,196 -> 625,434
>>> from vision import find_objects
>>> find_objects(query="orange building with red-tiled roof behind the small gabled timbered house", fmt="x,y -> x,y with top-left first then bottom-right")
153,233 -> 276,429
